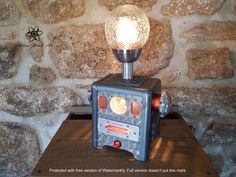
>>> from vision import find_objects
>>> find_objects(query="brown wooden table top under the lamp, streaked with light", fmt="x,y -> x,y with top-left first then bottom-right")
32,114 -> 219,177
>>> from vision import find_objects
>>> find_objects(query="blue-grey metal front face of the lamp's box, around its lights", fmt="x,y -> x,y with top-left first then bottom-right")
93,88 -> 150,160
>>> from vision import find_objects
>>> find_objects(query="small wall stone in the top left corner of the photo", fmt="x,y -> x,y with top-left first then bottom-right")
0,0 -> 20,26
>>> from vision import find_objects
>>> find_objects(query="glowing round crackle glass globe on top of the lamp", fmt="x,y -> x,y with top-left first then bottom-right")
105,5 -> 150,50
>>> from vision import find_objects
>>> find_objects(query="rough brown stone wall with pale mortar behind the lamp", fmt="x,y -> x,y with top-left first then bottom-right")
0,0 -> 236,177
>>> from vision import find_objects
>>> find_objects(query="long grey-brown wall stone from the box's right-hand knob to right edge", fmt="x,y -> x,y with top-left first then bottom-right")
164,87 -> 236,117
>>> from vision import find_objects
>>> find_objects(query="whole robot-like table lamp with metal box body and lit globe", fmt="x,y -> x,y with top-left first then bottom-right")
89,5 -> 171,161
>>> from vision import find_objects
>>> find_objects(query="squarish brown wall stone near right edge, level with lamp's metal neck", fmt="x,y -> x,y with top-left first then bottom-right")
186,48 -> 233,80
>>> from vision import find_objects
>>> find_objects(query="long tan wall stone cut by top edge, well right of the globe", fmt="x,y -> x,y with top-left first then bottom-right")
161,0 -> 223,16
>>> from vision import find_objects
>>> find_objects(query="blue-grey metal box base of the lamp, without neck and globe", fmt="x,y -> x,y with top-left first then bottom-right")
92,74 -> 167,161
